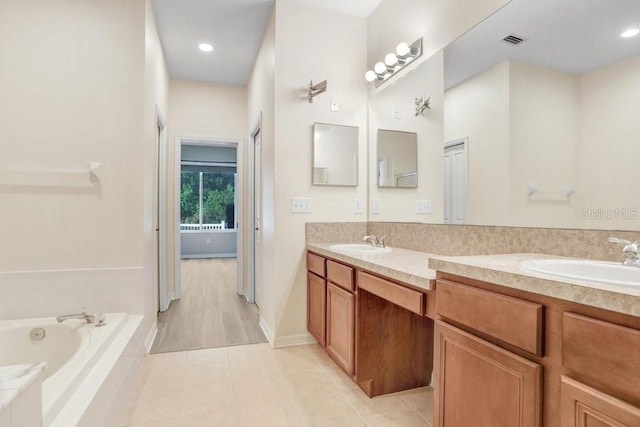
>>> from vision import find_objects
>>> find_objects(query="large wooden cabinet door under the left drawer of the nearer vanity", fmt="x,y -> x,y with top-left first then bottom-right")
434,321 -> 542,427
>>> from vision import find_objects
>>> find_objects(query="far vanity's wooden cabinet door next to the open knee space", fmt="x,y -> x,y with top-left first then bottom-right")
327,282 -> 356,375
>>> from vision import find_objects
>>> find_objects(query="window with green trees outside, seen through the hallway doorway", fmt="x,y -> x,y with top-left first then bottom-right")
180,168 -> 235,230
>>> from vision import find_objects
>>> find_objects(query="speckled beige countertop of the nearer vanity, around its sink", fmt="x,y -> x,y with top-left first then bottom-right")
429,253 -> 640,316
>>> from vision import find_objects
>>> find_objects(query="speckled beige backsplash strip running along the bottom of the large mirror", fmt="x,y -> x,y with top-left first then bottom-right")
367,222 -> 640,261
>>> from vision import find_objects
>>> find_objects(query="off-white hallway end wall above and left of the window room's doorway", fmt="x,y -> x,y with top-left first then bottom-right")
166,79 -> 247,293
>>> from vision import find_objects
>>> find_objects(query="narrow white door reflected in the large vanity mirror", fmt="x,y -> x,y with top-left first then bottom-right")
444,138 -> 467,224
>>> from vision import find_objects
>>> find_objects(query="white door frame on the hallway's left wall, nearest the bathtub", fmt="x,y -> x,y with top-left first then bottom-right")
154,105 -> 171,311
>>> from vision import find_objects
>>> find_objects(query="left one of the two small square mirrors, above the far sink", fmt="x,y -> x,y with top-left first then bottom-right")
312,123 -> 358,186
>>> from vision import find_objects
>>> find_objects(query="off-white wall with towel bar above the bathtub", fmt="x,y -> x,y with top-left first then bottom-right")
0,0 -> 152,318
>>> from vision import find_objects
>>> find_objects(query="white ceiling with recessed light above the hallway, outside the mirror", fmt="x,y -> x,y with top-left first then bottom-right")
151,0 -> 381,85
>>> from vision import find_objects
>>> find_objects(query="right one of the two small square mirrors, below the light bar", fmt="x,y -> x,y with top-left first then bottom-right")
377,129 -> 418,188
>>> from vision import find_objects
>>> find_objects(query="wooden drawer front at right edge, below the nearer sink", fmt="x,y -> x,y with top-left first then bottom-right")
562,313 -> 640,402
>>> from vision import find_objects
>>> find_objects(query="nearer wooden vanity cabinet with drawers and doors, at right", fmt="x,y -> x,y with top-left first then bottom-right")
434,272 -> 640,427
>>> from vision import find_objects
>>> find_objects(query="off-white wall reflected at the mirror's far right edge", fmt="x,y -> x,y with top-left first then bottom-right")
576,55 -> 640,230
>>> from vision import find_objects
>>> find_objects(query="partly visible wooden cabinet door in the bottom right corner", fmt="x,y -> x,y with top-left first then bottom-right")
560,376 -> 640,427
